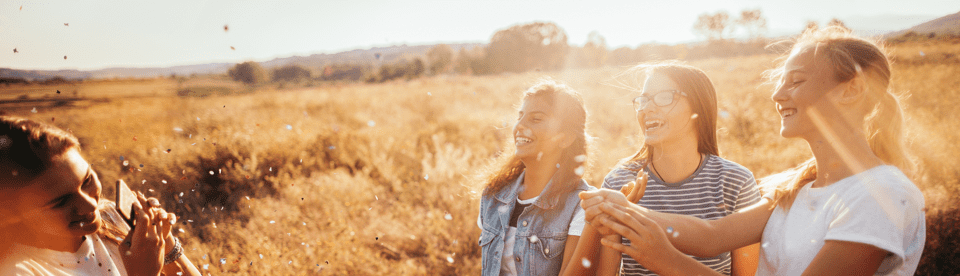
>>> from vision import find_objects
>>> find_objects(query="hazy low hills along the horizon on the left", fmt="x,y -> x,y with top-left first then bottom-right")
0,43 -> 484,80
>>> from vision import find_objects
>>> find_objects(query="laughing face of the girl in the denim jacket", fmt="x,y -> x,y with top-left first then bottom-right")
513,96 -> 565,166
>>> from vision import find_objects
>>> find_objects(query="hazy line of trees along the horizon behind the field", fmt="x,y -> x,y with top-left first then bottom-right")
221,9 -> 932,84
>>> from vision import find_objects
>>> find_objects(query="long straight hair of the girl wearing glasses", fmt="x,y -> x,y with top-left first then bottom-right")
616,61 -> 720,167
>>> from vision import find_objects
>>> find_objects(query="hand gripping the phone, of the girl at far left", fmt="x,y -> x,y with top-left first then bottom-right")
120,192 -> 170,276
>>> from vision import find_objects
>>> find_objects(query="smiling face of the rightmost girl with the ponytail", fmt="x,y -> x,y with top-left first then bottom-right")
771,45 -> 843,140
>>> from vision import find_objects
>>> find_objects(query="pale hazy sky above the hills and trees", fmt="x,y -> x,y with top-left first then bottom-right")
0,0 -> 960,70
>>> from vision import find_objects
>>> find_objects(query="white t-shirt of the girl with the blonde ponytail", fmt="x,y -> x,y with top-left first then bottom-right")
757,166 -> 926,275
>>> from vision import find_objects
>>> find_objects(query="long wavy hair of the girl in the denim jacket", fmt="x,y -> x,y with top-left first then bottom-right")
482,79 -> 588,198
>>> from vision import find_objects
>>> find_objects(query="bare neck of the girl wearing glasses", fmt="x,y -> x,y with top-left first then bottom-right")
650,140 -> 701,183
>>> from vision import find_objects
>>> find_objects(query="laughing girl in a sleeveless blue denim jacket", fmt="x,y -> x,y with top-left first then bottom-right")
477,80 -> 594,275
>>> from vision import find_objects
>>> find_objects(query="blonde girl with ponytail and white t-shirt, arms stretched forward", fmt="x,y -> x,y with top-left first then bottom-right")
581,27 -> 926,275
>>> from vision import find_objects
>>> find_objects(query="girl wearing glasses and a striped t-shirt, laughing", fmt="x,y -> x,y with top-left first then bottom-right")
566,62 -> 760,275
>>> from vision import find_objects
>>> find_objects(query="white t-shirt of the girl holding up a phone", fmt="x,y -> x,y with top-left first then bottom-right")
0,234 -> 127,276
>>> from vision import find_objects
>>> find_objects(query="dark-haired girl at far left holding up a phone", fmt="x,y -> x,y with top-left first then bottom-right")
0,116 -> 200,275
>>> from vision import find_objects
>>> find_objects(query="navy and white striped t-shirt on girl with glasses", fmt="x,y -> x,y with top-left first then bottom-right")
603,155 -> 760,275
